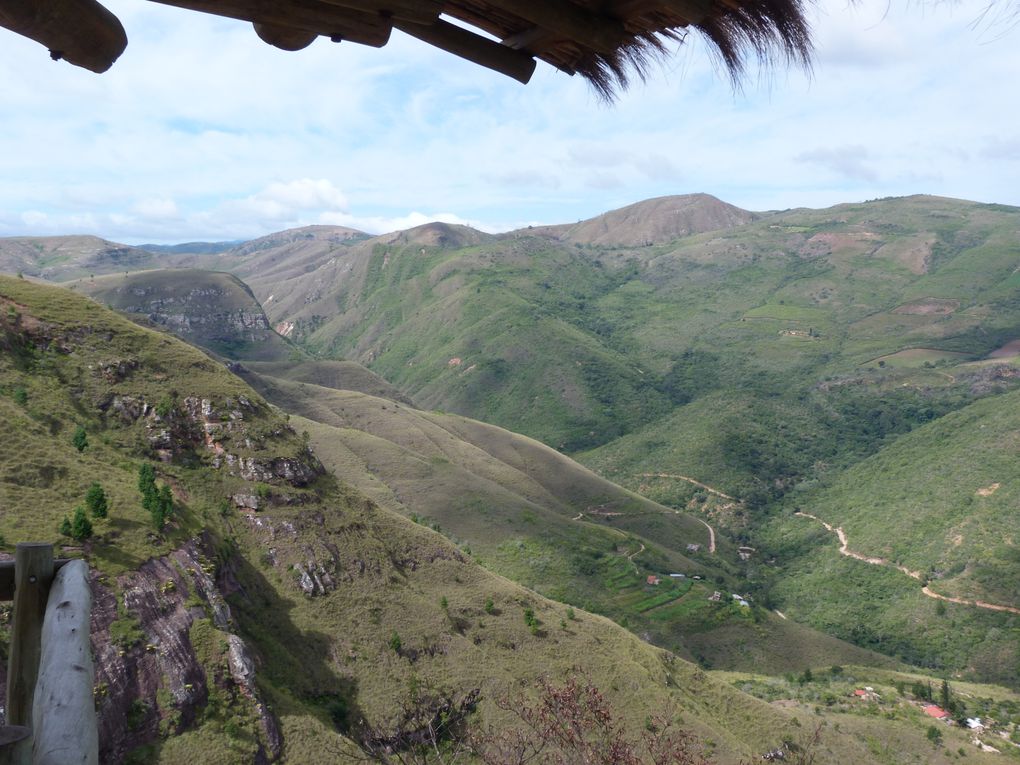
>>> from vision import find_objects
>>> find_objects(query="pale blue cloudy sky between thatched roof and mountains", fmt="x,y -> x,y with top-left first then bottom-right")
0,0 -> 1020,244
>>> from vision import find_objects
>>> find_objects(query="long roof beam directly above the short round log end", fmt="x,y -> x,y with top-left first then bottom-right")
145,0 -> 393,48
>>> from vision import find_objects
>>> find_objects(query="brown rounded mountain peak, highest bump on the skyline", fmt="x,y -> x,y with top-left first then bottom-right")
520,194 -> 761,247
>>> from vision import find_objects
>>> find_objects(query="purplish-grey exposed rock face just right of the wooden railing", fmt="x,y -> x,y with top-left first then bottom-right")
92,539 -> 283,763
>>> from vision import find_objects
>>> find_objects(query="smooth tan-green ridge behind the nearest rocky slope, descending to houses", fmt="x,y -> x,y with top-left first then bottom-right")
234,371 -> 884,671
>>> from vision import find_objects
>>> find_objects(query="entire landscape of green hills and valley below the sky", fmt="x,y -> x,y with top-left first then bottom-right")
0,190 -> 1020,763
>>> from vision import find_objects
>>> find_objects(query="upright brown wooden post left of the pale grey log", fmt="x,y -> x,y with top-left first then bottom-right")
7,543 -> 53,725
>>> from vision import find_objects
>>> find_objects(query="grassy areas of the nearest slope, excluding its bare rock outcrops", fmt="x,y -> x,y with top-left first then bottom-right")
0,278 -> 836,762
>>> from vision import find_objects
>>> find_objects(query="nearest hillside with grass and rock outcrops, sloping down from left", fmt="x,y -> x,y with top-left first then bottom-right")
0,277 -> 836,763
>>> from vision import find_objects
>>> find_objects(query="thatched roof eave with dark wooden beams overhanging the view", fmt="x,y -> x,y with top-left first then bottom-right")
0,0 -> 810,98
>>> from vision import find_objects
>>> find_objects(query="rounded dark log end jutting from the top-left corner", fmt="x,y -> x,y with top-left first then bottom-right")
0,0 -> 128,73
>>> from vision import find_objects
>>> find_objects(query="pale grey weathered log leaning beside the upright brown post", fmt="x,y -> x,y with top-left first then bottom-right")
32,560 -> 99,765
